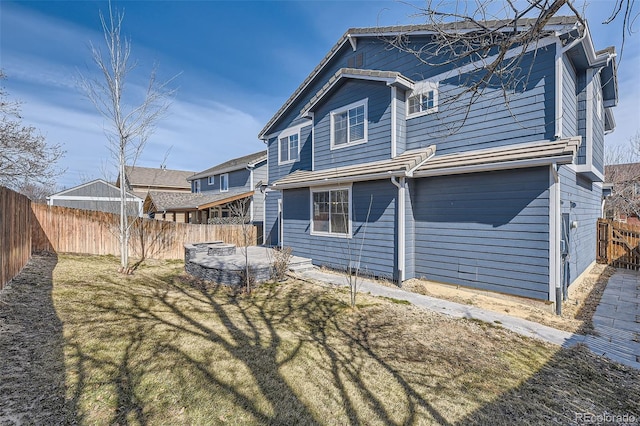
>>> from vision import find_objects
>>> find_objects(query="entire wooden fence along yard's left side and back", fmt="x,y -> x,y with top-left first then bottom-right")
0,186 -> 258,289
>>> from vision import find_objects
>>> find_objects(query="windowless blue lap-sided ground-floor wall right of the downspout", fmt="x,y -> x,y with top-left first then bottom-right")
412,167 -> 549,299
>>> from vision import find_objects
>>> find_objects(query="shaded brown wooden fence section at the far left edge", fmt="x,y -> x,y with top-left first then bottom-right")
0,186 -> 32,290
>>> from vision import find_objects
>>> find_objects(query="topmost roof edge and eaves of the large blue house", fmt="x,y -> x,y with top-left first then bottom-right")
258,16 -> 617,139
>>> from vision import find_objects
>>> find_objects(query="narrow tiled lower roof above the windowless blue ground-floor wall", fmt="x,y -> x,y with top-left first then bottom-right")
414,137 -> 581,177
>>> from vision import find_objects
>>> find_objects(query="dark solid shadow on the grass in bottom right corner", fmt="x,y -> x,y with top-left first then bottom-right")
456,346 -> 640,425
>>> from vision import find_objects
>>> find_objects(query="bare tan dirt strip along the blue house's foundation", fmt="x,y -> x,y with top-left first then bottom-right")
402,265 -> 615,334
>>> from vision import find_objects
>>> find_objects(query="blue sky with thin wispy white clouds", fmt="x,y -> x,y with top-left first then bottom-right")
0,0 -> 640,187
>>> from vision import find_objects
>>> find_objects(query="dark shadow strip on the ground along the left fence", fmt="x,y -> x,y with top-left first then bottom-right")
0,253 -> 76,424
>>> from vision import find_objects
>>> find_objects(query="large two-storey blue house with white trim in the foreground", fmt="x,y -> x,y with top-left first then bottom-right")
259,17 -> 617,301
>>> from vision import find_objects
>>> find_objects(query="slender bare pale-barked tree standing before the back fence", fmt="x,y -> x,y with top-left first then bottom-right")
79,3 -> 173,272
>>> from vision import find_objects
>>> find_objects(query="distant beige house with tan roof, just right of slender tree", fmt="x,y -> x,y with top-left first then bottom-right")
116,166 -> 194,200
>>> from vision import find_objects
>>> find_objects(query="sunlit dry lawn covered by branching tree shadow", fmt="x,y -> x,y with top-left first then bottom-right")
70,268 -> 456,425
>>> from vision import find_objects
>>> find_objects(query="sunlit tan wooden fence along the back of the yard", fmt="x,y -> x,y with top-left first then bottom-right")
32,203 -> 257,259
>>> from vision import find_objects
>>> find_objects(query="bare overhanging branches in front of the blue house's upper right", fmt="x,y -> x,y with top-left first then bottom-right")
387,0 -> 638,134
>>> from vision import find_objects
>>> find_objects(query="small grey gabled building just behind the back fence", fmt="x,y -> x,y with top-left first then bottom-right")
47,179 -> 143,216
